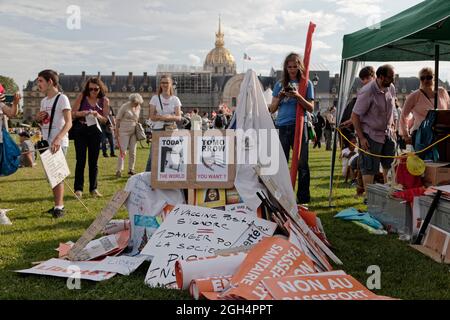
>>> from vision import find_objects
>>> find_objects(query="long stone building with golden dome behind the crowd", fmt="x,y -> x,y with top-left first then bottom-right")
23,20 -> 442,122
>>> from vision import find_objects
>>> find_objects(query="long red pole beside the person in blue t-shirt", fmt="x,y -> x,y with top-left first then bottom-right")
287,22 -> 316,188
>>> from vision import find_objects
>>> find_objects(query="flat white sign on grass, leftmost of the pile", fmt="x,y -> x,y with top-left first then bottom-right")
16,259 -> 116,281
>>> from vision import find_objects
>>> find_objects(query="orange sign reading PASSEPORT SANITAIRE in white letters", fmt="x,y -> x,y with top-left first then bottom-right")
222,237 -> 315,300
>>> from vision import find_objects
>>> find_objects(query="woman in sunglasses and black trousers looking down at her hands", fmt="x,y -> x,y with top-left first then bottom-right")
72,78 -> 109,198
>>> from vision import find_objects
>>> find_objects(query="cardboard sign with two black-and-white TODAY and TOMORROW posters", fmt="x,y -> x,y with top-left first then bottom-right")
151,130 -> 236,189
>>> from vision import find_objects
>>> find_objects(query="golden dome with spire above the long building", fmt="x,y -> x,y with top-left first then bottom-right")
203,19 -> 236,75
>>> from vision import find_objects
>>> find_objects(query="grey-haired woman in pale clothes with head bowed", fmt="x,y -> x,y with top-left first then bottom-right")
115,93 -> 144,178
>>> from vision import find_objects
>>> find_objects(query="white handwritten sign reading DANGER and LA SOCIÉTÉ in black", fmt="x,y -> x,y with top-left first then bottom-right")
141,205 -> 276,286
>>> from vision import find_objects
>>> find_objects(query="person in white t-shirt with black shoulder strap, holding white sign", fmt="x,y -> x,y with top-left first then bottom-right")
35,69 -> 72,218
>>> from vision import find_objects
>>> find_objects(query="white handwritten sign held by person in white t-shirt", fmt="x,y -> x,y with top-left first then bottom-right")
41,148 -> 70,189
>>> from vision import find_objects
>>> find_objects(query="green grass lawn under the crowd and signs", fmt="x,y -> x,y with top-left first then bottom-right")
0,138 -> 450,299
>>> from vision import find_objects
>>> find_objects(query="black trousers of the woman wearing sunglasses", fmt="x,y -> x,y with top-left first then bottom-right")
74,125 -> 102,192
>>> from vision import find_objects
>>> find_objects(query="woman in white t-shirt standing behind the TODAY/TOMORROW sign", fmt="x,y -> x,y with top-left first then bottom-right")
145,75 -> 181,171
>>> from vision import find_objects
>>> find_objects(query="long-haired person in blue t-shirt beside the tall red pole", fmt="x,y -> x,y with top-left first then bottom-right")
269,53 -> 314,203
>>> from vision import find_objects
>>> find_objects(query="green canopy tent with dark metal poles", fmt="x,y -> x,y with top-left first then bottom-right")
329,0 -> 450,206
